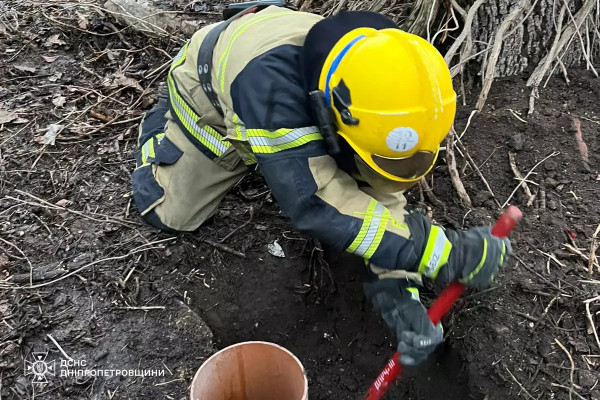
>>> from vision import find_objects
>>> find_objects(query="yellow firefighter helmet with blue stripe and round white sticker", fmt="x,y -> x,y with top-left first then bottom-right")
319,28 -> 456,191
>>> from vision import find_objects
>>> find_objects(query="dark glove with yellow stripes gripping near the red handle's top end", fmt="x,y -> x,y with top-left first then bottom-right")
425,226 -> 512,289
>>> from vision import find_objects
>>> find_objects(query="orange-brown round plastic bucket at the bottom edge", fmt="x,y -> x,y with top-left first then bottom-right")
191,342 -> 308,400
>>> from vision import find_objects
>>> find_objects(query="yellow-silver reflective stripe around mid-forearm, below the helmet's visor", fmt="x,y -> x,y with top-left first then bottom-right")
346,199 -> 390,259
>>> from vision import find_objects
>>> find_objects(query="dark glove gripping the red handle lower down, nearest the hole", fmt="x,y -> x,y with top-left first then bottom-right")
365,279 -> 444,365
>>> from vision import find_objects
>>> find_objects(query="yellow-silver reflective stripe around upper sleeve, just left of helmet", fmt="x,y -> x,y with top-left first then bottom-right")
246,126 -> 323,154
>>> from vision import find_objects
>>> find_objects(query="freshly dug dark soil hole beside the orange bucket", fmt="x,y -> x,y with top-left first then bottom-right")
192,255 -> 483,400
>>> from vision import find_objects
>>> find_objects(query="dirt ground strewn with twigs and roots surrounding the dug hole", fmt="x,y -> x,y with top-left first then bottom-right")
0,0 -> 600,400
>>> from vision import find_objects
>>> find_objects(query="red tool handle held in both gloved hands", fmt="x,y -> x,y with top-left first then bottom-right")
365,206 -> 523,400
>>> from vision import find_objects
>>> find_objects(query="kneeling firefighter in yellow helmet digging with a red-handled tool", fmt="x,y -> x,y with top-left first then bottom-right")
132,6 -> 511,365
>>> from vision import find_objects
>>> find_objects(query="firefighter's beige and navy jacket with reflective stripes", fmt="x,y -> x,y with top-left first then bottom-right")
159,6 -> 450,277
